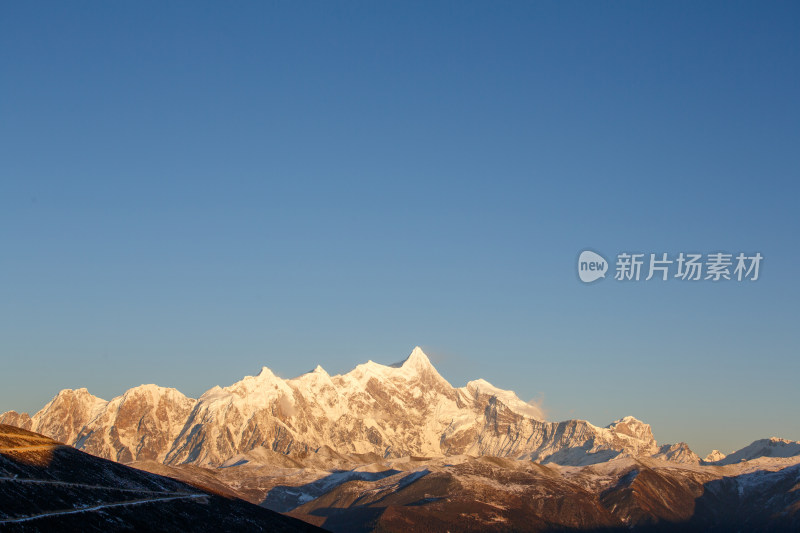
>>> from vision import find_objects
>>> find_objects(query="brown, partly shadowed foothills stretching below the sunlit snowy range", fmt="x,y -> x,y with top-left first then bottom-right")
131,455 -> 800,532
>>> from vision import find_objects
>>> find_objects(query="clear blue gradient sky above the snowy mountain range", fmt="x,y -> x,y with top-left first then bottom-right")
0,2 -> 800,453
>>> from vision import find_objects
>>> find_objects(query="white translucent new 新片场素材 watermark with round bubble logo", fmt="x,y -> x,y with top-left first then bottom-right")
578,250 -> 764,283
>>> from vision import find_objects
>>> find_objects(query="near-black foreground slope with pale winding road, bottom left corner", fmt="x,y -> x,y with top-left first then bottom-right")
0,425 -> 318,532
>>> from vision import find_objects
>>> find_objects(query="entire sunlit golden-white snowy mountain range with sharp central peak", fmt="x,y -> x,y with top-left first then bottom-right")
0,347 -> 788,466
